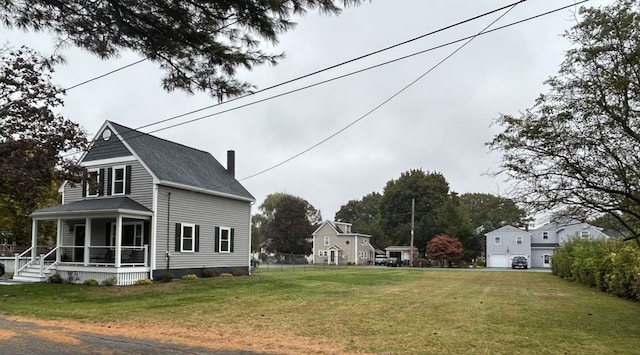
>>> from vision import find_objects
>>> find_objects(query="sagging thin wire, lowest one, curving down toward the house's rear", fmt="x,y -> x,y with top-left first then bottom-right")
238,2 -> 520,181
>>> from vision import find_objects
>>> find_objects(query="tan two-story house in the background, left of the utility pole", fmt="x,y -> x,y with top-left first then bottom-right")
311,221 -> 375,265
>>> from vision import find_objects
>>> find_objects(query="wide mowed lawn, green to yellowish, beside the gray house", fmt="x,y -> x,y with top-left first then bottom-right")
0,268 -> 640,354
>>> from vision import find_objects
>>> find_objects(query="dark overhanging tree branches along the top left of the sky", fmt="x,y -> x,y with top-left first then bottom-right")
0,0 -> 362,98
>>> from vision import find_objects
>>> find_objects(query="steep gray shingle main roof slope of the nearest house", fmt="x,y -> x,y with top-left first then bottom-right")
109,121 -> 255,200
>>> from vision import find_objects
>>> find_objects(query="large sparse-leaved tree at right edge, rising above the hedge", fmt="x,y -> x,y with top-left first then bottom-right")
488,0 -> 640,242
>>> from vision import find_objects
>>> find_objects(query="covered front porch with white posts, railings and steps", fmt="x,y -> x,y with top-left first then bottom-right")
14,197 -> 153,285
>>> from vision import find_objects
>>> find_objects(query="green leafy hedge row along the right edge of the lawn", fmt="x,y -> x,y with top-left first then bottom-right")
551,239 -> 640,300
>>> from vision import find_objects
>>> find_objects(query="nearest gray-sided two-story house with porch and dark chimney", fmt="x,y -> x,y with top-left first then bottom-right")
14,121 -> 255,285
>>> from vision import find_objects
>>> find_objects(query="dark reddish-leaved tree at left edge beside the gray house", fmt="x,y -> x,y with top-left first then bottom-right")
0,47 -> 87,242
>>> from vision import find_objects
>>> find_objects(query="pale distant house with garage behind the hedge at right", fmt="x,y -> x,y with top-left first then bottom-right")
485,220 -> 609,268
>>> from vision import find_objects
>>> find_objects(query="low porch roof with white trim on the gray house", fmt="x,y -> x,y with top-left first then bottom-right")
31,196 -> 153,219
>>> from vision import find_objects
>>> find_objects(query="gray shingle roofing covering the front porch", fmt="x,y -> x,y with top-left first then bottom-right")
32,196 -> 152,217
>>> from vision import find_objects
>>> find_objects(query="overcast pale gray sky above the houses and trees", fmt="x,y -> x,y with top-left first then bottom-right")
0,0 -> 610,220
